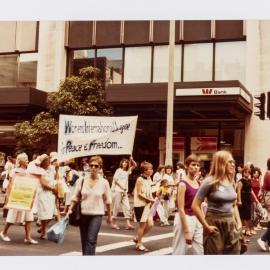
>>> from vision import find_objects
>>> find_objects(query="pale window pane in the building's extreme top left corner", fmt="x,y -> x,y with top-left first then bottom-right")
0,22 -> 16,52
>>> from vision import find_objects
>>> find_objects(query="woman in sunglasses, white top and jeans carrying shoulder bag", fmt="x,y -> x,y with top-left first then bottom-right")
67,156 -> 112,255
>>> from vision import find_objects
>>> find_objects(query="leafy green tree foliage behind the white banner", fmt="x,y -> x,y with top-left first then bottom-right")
15,67 -> 112,153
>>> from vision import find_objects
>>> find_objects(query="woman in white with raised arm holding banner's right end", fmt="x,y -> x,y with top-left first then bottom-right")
111,157 -> 137,230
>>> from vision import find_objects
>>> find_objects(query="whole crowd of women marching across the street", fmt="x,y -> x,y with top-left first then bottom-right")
0,150 -> 270,255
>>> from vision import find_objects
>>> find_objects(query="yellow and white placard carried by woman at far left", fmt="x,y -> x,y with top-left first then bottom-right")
5,175 -> 39,211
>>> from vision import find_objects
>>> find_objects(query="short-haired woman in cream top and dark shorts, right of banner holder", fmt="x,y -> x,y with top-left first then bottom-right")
133,161 -> 154,252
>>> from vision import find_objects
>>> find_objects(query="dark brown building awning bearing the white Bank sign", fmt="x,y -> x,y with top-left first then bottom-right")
106,81 -> 253,122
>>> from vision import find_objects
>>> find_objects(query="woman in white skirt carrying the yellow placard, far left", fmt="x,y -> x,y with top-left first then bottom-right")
0,153 -> 38,244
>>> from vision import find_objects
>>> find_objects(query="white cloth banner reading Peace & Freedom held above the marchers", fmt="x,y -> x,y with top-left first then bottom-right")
58,115 -> 138,160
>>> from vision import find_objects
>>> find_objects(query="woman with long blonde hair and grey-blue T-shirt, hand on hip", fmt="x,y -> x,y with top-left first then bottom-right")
192,151 -> 242,255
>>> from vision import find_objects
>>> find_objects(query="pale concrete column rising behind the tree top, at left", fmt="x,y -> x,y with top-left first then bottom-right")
37,21 -> 67,92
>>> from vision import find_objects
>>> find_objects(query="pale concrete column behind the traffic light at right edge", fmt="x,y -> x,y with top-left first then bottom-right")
245,20 -> 270,171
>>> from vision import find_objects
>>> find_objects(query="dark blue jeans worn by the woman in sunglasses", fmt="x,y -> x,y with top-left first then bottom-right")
80,215 -> 102,255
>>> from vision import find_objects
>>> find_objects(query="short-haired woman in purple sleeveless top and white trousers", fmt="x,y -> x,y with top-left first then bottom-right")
172,154 -> 203,255
